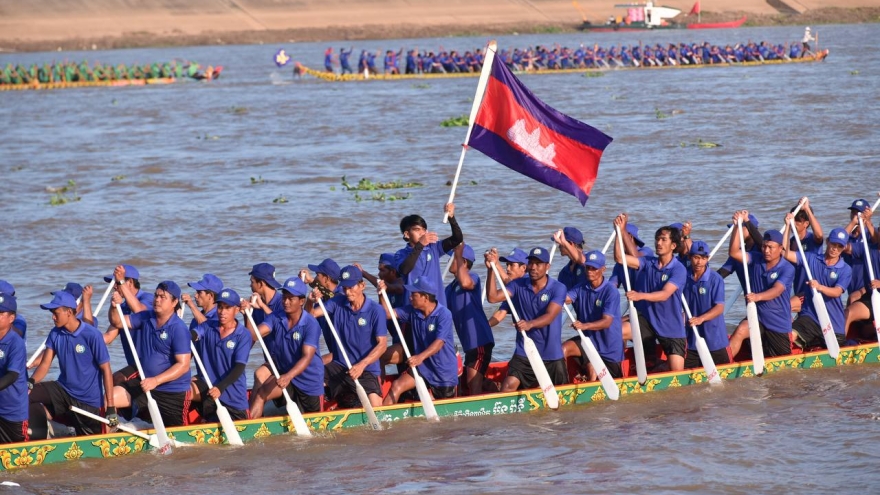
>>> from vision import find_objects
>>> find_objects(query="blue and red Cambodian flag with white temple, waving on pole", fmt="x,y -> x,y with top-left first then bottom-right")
467,57 -> 612,205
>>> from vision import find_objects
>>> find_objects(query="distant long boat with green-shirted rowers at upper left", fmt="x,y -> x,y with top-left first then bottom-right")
0,60 -> 223,91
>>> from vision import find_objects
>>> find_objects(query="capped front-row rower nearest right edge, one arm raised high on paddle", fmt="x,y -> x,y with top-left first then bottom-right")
783,227 -> 852,349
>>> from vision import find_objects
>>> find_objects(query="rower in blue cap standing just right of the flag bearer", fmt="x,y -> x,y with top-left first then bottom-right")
446,243 -> 497,395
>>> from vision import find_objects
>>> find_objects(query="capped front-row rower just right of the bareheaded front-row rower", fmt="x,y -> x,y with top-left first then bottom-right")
683,241 -> 733,369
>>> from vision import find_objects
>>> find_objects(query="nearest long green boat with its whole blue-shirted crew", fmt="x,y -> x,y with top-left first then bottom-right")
0,193 -> 880,470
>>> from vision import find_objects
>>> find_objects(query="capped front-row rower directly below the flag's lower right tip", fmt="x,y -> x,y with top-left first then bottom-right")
562,251 -> 623,381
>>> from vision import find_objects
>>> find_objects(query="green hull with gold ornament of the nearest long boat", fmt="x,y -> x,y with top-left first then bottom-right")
0,343 -> 880,470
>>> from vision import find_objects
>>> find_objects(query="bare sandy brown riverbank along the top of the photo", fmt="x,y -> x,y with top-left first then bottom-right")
0,0 -> 880,51
